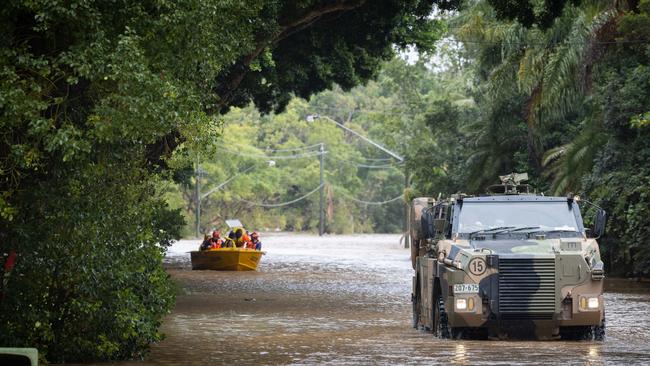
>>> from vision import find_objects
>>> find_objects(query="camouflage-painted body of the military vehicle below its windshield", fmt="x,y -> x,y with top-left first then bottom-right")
412,194 -> 604,339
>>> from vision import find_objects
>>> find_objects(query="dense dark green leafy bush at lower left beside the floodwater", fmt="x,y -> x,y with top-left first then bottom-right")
0,159 -> 183,361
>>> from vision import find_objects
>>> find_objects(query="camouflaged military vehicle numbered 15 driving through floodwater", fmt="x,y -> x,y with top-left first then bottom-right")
410,173 -> 606,340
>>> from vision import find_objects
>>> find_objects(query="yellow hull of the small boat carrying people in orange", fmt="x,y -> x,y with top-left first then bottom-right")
190,248 -> 265,271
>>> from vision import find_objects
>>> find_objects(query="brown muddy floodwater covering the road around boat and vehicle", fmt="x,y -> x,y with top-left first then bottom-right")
101,234 -> 650,366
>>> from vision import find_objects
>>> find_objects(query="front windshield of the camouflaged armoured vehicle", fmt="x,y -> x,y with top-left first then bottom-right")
457,201 -> 580,234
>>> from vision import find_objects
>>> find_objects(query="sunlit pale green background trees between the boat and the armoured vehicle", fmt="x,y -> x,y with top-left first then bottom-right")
175,55 -> 484,233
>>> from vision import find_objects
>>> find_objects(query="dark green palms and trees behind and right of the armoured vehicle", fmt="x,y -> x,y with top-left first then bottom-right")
452,0 -> 650,275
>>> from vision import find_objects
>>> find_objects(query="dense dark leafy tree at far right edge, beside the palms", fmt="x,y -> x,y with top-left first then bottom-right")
585,1 -> 650,276
